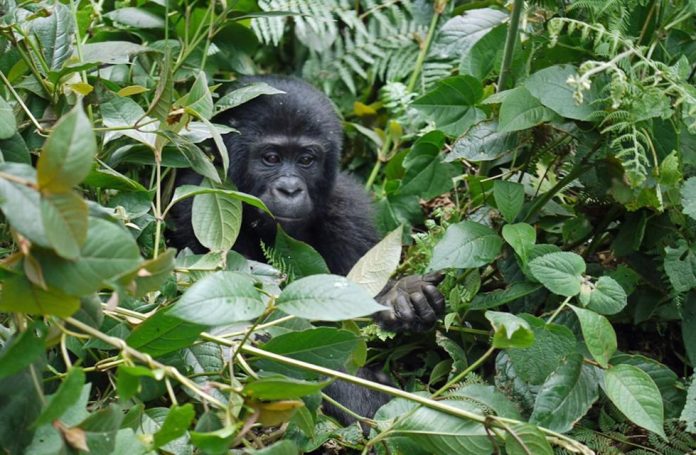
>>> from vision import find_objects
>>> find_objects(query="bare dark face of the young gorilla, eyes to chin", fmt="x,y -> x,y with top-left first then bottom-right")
247,135 -> 326,227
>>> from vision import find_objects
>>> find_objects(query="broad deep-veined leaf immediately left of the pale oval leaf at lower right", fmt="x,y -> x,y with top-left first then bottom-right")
529,353 -> 599,433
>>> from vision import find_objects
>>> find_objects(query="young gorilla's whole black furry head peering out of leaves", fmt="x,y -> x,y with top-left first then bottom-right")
222,77 -> 343,230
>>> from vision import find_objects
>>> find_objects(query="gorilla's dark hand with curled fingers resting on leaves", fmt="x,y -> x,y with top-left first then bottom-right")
374,272 -> 445,332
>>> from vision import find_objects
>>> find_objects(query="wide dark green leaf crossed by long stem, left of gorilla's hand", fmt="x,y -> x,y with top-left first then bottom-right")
257,327 -> 360,377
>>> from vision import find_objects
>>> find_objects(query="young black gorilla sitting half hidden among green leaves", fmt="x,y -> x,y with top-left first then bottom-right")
168,76 -> 444,423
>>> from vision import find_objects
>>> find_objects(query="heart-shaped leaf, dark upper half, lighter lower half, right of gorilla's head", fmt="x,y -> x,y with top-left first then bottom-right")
412,76 -> 486,136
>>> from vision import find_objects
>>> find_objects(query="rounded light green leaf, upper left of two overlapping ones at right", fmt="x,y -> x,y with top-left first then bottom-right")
529,251 -> 585,297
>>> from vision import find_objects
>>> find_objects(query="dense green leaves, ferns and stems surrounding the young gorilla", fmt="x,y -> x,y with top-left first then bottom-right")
0,0 -> 696,455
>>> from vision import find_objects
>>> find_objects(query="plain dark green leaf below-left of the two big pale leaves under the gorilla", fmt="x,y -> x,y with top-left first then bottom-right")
126,310 -> 206,357
